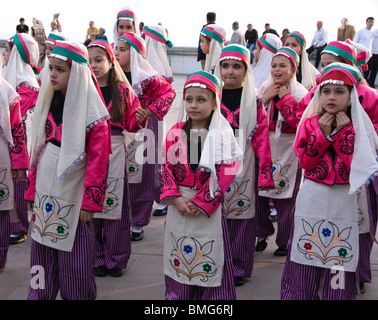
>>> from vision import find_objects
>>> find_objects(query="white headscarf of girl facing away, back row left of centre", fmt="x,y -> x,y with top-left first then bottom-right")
144,26 -> 173,79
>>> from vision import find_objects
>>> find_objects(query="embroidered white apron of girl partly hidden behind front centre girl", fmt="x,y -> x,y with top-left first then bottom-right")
224,142 -> 255,219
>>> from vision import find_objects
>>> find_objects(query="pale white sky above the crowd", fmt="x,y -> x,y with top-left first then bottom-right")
0,0 -> 378,47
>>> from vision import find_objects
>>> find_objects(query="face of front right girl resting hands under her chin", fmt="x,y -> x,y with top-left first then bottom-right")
320,84 -> 350,114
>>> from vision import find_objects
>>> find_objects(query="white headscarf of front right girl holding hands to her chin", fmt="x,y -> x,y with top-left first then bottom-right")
296,63 -> 378,193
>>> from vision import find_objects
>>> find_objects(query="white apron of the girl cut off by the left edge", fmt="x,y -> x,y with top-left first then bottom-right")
0,137 -> 14,211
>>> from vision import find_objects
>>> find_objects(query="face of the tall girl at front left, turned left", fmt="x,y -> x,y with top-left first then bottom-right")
49,58 -> 71,95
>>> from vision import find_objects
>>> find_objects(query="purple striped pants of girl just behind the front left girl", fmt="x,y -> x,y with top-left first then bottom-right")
93,173 -> 131,269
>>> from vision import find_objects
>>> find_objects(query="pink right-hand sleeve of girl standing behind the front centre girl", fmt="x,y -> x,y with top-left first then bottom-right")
252,99 -> 274,188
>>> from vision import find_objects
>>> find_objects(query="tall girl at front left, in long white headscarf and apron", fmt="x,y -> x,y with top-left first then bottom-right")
25,41 -> 111,300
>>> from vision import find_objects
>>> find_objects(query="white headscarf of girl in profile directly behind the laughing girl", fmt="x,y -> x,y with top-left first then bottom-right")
253,33 -> 282,89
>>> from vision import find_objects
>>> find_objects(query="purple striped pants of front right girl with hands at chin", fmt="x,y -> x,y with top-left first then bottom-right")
281,231 -> 357,300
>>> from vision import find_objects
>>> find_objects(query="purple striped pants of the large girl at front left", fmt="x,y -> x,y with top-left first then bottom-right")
28,221 -> 97,300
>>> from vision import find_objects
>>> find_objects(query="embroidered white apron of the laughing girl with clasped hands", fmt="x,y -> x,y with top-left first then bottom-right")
259,131 -> 298,199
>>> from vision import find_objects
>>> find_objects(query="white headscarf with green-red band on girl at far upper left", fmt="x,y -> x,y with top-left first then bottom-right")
3,33 -> 39,90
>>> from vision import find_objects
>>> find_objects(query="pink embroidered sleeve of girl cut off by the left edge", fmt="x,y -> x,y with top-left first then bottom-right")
10,100 -> 29,170
